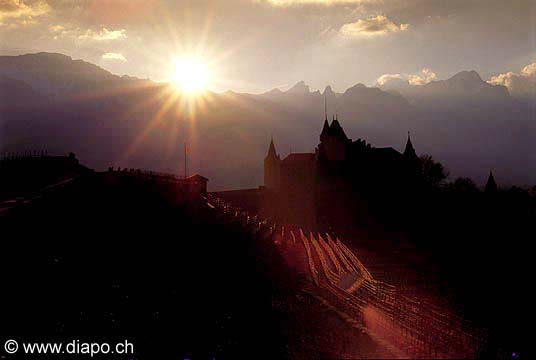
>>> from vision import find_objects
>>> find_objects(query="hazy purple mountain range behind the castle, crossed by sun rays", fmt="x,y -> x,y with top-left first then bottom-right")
0,53 -> 536,189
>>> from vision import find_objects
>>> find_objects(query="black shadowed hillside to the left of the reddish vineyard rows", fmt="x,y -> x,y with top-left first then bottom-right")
0,174 -> 386,359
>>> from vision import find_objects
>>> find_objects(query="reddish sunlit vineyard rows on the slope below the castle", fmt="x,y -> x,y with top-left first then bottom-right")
207,195 -> 487,358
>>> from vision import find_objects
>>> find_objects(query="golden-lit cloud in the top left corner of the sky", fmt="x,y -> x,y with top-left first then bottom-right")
0,0 -> 50,26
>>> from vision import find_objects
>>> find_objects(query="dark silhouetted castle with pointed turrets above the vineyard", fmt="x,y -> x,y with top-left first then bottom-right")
261,116 -> 420,229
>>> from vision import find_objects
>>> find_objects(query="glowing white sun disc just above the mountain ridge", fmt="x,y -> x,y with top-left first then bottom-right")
172,58 -> 211,94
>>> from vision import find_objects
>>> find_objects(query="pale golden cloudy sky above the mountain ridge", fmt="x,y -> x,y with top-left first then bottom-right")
0,0 -> 536,93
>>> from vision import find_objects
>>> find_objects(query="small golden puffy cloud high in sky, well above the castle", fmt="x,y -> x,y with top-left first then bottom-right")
340,15 -> 409,38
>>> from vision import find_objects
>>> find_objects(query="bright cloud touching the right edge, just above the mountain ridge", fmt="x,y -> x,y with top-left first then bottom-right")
488,62 -> 536,97
